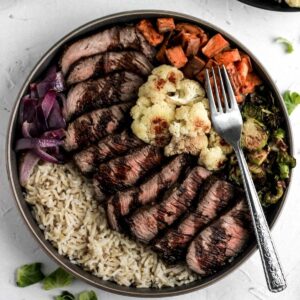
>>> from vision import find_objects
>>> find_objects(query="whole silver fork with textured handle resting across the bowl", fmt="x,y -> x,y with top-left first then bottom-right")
205,66 -> 286,292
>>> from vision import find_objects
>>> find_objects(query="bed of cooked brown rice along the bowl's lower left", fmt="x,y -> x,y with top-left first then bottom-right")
25,163 -> 198,288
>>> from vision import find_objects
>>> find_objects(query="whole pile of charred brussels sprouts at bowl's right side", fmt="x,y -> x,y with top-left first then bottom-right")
225,86 -> 296,206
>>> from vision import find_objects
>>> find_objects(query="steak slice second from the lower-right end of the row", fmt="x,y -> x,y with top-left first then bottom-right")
153,176 -> 234,263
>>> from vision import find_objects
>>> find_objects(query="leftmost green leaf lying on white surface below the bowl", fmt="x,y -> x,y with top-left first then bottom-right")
16,263 -> 45,287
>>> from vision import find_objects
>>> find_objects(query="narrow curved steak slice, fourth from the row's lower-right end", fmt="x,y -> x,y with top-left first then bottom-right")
106,155 -> 188,231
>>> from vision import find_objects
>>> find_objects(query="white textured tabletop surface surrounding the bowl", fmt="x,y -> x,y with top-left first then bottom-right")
0,0 -> 300,300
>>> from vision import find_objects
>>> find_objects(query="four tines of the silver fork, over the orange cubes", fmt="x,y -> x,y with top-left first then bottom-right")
205,65 -> 237,113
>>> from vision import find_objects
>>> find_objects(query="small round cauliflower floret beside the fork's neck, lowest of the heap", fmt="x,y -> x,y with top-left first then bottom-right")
198,146 -> 227,171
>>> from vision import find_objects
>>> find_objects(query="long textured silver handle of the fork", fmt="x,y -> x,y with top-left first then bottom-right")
234,144 -> 286,292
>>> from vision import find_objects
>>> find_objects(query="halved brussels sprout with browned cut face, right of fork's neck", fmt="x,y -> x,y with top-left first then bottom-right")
241,118 -> 269,151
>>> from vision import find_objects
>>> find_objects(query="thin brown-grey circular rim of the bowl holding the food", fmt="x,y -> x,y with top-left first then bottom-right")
6,10 -> 294,297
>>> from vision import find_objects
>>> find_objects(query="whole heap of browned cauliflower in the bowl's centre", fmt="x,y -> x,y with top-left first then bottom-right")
131,65 -> 232,170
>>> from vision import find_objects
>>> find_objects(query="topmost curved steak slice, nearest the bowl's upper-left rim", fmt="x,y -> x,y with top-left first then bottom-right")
60,26 -> 155,75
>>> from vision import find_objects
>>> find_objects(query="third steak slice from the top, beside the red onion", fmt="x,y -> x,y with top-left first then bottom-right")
63,72 -> 143,120
